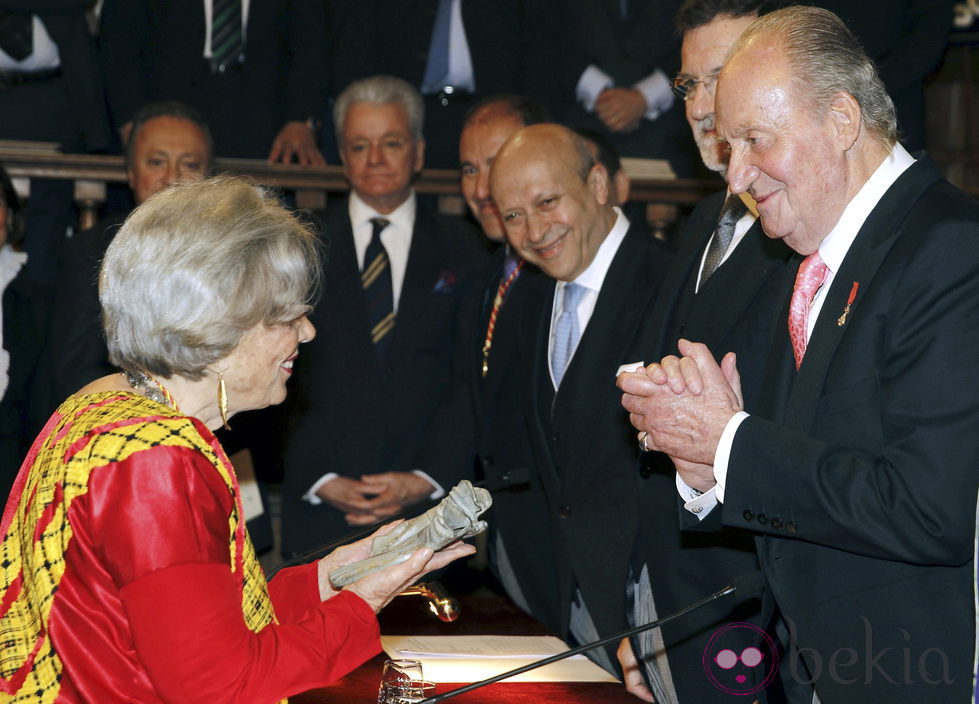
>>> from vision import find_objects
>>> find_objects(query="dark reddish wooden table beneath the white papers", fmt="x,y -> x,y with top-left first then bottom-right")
289,596 -> 639,704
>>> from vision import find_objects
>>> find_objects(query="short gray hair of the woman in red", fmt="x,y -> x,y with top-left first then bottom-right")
99,177 -> 320,379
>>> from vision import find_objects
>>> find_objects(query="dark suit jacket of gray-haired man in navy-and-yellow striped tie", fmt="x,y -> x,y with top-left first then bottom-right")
283,199 -> 485,553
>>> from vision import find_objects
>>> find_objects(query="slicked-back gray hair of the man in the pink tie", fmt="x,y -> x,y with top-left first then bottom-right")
731,5 -> 897,145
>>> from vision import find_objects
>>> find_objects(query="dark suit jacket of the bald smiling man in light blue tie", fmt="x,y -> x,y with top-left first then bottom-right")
527,223 -> 670,648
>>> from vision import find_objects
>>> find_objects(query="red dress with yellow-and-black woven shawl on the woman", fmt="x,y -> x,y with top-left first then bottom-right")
0,393 -> 380,704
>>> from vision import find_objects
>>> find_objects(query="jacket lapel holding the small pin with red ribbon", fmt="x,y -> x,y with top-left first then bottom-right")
785,163 -> 938,429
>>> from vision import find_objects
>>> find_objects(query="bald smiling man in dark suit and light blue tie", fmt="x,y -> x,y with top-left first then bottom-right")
490,125 -> 669,669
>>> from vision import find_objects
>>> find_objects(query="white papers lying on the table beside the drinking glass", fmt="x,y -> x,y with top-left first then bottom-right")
381,635 -> 618,682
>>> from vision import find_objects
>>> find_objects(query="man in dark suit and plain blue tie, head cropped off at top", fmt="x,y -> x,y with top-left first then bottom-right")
327,0 -> 557,169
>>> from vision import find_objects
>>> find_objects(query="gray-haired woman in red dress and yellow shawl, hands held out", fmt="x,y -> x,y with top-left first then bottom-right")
0,179 -> 472,703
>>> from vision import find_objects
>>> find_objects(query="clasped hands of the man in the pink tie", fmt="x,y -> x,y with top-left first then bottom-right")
616,340 -> 744,490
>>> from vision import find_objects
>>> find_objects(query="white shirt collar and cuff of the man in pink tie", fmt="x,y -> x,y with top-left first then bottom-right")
677,144 -> 914,518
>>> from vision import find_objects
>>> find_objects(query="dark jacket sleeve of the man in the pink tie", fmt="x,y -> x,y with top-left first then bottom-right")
724,214 -> 979,565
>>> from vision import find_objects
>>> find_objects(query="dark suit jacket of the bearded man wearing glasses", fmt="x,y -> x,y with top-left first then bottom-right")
633,191 -> 791,702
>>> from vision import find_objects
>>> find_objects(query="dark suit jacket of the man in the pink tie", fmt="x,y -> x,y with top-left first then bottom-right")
722,161 -> 979,704
